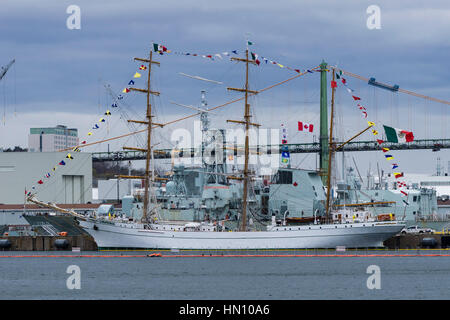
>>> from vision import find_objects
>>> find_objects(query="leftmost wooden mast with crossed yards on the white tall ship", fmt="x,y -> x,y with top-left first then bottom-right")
118,50 -> 163,223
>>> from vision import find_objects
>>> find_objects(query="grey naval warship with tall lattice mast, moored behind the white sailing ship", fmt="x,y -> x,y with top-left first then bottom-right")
122,91 -> 326,229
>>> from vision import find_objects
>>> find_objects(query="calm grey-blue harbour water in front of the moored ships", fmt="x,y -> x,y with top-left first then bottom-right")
0,252 -> 450,300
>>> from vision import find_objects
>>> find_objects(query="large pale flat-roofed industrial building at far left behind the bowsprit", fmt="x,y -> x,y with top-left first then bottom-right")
0,152 -> 92,204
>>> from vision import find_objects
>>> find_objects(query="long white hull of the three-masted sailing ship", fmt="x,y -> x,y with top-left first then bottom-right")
80,220 -> 405,250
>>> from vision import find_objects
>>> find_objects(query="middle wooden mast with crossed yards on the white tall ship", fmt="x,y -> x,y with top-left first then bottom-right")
227,49 -> 260,231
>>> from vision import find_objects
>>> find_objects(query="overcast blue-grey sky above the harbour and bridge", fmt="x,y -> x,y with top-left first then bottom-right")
0,0 -> 450,173
